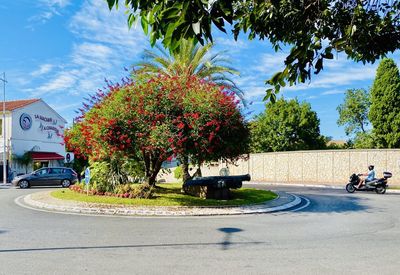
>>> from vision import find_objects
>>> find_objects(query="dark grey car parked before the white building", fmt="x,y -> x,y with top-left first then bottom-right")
12,167 -> 78,189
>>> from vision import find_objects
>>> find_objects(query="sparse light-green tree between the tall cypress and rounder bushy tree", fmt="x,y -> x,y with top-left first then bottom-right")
336,89 -> 371,135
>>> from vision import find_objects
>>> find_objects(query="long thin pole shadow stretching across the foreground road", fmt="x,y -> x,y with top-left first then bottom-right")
0,242 -> 265,254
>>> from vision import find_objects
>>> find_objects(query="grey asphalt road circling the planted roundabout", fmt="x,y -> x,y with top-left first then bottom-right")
0,185 -> 400,274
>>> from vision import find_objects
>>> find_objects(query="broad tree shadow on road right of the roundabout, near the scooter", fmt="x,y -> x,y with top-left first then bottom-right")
297,194 -> 369,213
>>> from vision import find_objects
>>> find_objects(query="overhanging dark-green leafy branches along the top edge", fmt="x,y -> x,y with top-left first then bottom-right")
107,0 -> 400,100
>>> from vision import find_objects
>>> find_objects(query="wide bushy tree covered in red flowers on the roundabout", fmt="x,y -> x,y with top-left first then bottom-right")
65,75 -> 248,185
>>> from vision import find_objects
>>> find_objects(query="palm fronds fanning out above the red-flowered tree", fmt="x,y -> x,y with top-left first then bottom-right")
134,40 -> 245,101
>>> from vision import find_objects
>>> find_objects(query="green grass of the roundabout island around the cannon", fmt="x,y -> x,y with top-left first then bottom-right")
51,183 -> 277,206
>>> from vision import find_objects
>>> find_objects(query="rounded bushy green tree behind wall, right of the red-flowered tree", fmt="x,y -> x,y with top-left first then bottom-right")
250,98 -> 325,152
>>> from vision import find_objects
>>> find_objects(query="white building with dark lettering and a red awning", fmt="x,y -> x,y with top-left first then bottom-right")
0,99 -> 67,179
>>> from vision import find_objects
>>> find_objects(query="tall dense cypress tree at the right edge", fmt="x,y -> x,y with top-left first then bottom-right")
369,59 -> 400,148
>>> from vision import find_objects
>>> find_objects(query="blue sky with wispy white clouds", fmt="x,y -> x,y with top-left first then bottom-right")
0,0 -> 400,139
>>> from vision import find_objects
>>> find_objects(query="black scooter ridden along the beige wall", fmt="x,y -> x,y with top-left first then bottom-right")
346,172 -> 392,194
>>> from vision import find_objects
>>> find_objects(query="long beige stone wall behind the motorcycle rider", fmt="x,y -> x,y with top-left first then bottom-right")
163,149 -> 400,185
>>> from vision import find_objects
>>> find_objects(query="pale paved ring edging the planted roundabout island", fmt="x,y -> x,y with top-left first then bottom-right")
16,191 -> 302,216
